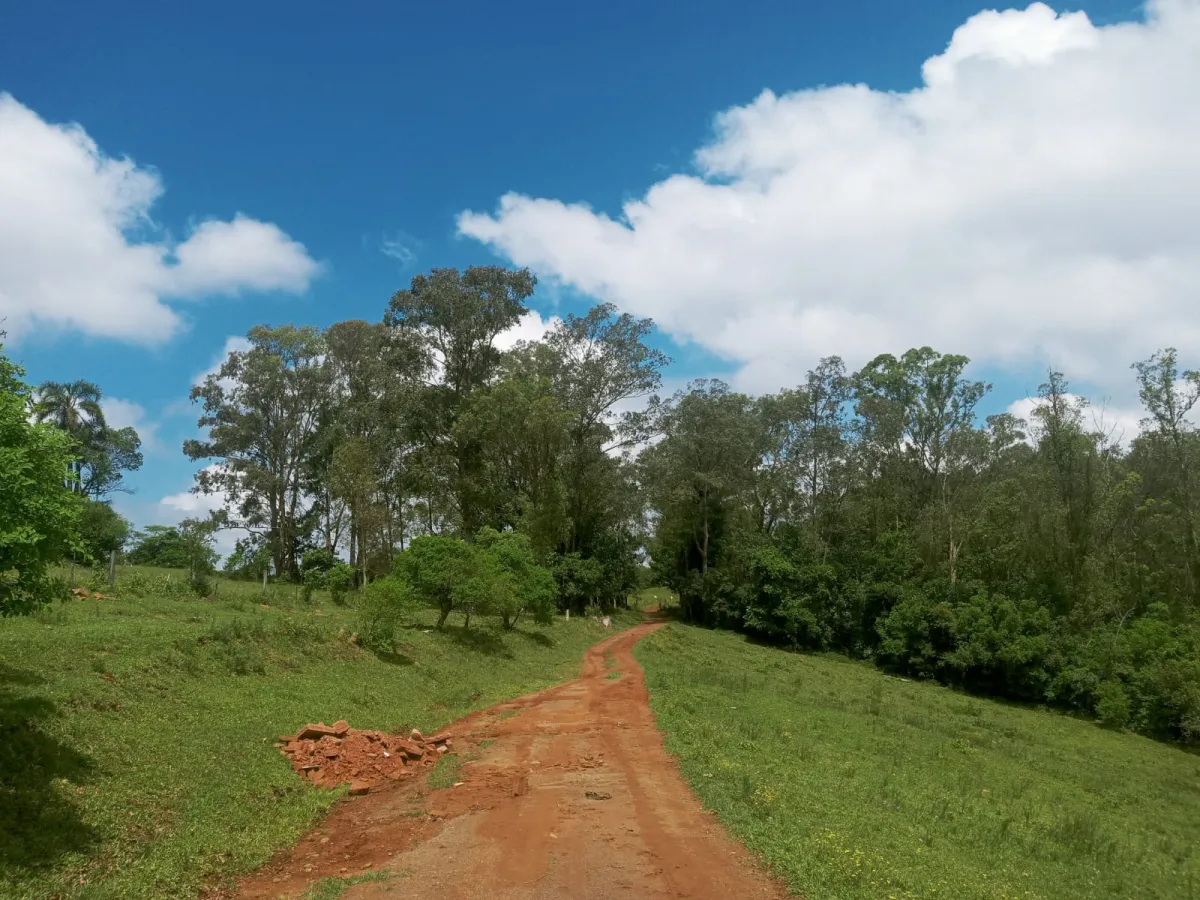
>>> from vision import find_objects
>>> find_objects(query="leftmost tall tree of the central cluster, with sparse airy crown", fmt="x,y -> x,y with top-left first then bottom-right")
184,325 -> 329,577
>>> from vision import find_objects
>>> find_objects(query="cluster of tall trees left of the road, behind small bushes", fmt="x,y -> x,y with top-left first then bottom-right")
184,266 -> 668,608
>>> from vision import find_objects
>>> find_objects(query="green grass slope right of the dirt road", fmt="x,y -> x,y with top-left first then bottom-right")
635,625 -> 1200,900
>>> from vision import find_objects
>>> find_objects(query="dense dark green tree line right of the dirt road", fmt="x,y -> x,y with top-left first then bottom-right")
638,348 -> 1200,738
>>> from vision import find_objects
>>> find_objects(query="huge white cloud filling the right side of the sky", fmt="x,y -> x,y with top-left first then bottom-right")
458,0 -> 1200,394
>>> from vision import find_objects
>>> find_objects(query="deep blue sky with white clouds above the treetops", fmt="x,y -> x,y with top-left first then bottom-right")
0,0 -> 1200,540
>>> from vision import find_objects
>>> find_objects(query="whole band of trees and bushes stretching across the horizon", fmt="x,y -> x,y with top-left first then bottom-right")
0,266 -> 1200,742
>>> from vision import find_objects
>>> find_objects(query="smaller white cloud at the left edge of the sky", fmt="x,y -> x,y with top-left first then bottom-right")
0,94 -> 320,343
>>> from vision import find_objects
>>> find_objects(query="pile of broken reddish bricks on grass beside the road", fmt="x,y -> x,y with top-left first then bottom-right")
275,721 -> 451,794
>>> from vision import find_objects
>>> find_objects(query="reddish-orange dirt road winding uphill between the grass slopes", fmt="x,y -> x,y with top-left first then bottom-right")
241,624 -> 786,900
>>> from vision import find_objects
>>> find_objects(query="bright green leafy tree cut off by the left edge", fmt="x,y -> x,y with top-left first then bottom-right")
0,343 -> 80,616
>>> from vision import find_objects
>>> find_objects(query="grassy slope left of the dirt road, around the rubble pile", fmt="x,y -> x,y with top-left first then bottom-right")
0,571 -> 636,898
